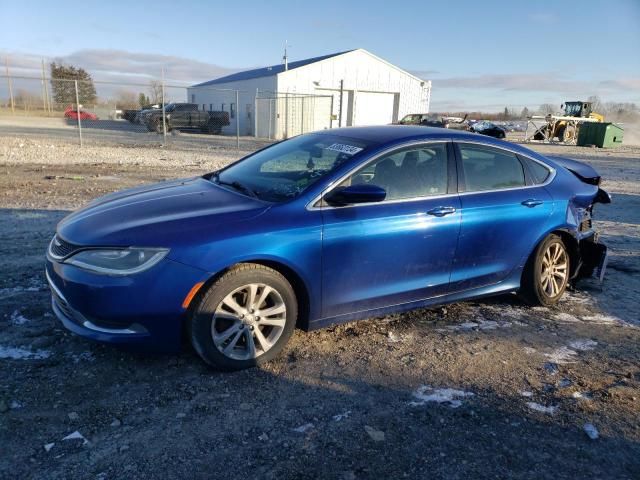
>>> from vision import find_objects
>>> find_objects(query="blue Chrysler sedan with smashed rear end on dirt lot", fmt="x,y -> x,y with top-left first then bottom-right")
46,126 -> 610,370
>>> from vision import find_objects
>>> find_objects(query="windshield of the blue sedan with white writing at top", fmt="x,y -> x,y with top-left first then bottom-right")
211,134 -> 373,202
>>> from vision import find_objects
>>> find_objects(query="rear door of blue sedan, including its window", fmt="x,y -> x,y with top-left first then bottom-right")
451,142 -> 554,293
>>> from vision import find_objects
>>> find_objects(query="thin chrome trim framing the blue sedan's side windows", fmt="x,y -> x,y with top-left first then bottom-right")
305,139 -> 556,211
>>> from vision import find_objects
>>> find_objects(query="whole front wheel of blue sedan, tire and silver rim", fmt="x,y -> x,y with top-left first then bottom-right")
188,263 -> 298,371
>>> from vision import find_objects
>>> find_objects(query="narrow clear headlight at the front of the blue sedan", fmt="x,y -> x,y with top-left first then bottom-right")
64,247 -> 169,275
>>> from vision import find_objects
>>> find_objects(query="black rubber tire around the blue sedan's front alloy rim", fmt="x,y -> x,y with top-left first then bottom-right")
187,263 -> 298,371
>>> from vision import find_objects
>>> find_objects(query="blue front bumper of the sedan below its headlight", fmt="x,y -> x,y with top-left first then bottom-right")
45,259 -> 208,351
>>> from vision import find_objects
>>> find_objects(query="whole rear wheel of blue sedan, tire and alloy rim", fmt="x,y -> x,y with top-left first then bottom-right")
519,234 -> 571,306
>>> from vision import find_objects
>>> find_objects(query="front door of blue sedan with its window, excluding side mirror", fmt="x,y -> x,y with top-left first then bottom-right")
321,142 -> 460,318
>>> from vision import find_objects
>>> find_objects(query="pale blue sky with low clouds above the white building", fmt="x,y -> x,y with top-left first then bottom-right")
0,0 -> 640,111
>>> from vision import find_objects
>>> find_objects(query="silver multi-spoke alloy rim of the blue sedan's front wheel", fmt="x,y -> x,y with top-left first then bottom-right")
211,283 -> 287,360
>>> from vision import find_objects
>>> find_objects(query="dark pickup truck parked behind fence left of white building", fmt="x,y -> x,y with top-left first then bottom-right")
143,103 -> 230,135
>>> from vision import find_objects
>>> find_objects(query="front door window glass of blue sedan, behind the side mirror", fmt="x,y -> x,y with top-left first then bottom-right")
341,143 -> 448,200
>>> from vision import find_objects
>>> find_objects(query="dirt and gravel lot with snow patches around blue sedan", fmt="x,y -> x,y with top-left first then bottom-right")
0,136 -> 640,479
